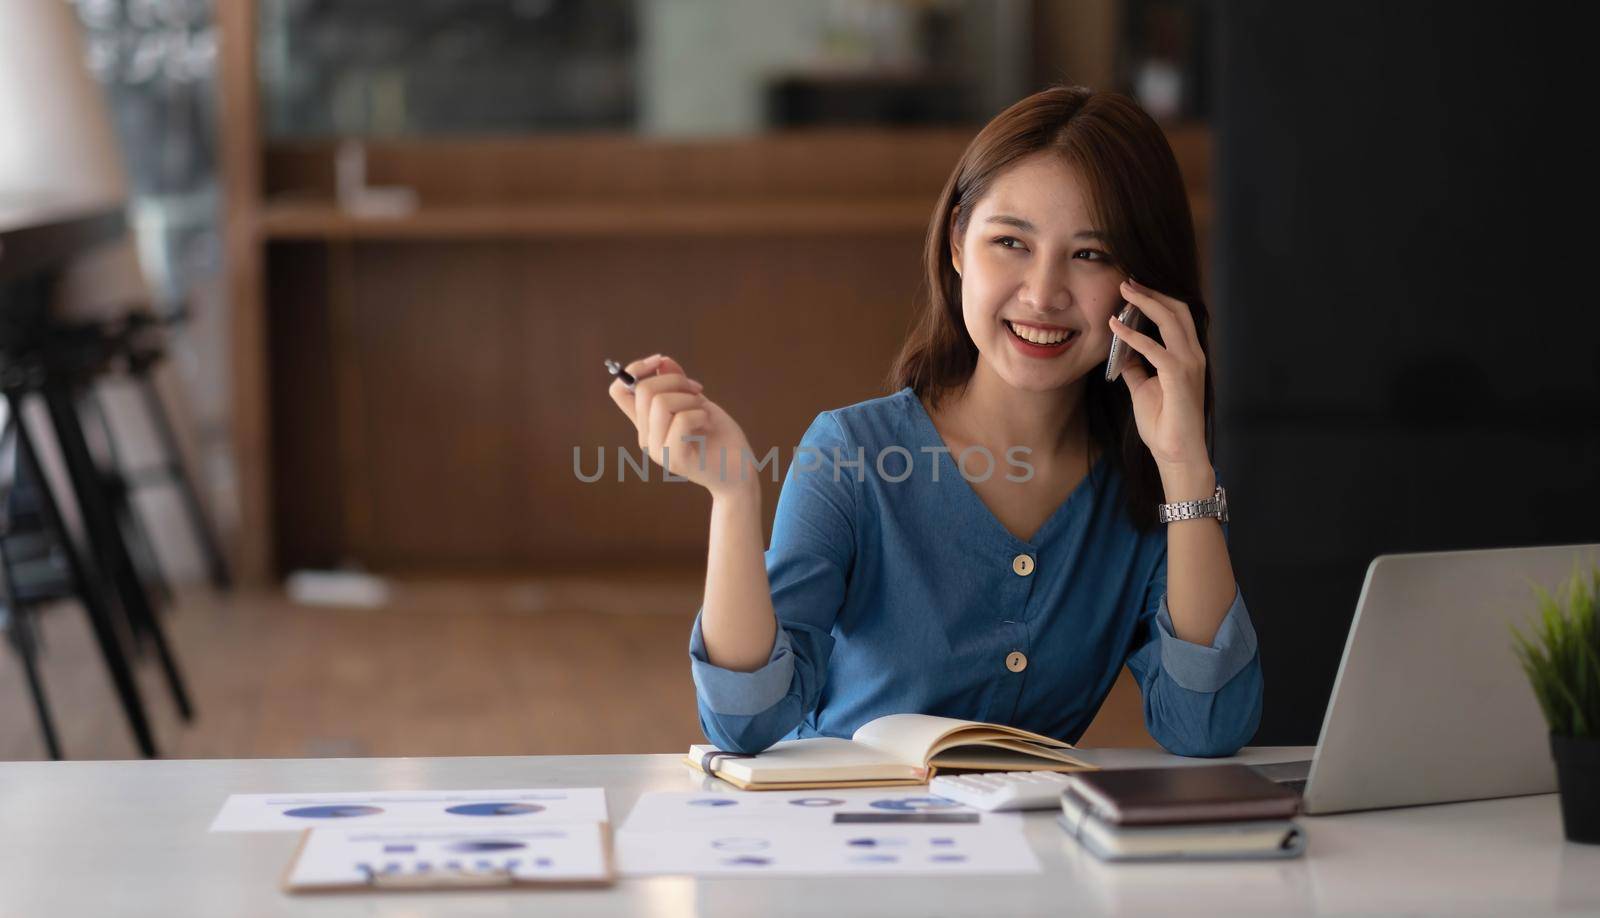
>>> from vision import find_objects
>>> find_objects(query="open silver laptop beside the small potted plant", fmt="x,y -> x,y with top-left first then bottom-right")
1259,544 -> 1600,814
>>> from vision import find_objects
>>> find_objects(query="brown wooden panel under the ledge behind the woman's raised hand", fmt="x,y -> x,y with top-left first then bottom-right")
274,235 -> 920,569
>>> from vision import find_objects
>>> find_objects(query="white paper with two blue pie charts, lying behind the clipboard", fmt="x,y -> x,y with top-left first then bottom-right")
211,787 -> 606,832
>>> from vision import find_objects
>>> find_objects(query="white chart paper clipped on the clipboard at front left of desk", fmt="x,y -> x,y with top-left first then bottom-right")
290,822 -> 610,889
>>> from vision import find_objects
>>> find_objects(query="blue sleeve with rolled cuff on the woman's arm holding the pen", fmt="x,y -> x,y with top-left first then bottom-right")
690,411 -> 858,753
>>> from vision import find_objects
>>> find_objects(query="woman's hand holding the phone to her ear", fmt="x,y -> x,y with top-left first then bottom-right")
1110,278 -> 1211,477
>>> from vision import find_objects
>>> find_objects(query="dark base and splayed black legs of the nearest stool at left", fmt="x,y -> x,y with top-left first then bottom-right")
0,204 -> 192,756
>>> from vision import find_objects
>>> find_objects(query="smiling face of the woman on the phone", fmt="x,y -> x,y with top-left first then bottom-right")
950,152 -> 1126,392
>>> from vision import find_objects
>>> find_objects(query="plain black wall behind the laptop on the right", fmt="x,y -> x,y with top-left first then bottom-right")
1211,0 -> 1600,744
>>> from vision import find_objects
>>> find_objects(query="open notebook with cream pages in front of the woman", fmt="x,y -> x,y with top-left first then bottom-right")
686,713 -> 1094,790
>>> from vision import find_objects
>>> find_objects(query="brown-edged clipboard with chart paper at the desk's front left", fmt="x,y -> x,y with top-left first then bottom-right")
280,822 -> 616,896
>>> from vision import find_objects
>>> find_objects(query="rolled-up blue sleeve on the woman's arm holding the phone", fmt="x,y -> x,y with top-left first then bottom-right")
1128,536 -> 1262,756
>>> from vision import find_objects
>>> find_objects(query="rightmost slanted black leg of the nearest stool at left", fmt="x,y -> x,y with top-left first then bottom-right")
43,384 -> 194,721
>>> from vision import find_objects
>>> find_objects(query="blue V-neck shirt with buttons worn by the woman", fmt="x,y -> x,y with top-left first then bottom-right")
690,387 -> 1261,755
